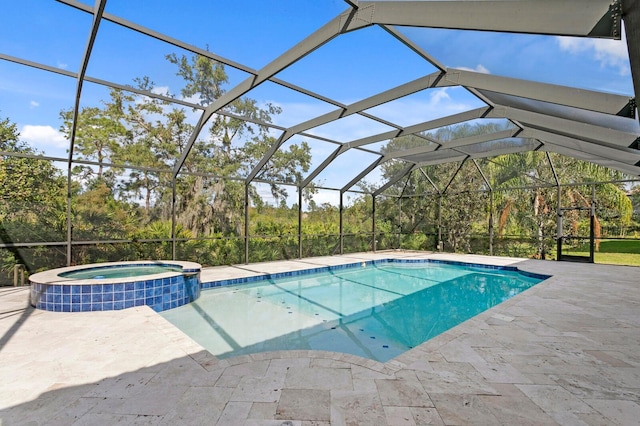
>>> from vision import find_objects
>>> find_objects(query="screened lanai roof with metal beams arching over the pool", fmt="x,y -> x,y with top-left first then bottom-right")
0,0 -> 640,193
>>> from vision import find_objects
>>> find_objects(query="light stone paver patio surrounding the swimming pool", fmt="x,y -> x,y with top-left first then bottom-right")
0,252 -> 640,425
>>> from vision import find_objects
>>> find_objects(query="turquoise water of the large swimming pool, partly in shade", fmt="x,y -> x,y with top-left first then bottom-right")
161,263 -> 542,362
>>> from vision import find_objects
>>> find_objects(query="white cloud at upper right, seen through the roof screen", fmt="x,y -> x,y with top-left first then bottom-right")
556,31 -> 630,75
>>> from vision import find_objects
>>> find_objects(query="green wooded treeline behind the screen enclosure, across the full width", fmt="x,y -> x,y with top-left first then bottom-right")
0,55 -> 640,280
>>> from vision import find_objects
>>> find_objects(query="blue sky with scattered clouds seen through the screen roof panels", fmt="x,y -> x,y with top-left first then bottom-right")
0,0 -> 633,205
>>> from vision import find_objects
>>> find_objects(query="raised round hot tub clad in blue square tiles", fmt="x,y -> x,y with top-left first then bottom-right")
29,260 -> 202,312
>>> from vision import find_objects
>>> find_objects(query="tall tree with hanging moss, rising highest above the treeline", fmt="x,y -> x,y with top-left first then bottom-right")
159,54 -> 311,235
